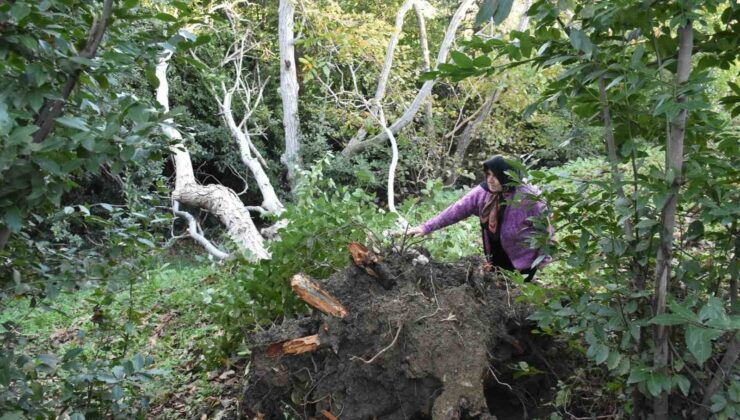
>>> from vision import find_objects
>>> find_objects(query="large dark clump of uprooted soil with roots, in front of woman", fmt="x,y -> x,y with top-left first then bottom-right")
244,254 -> 568,419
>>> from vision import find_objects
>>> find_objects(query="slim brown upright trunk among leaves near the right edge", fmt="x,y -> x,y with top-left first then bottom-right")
653,21 -> 694,420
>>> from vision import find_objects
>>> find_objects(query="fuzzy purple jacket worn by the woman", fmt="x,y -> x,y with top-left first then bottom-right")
421,185 -> 553,270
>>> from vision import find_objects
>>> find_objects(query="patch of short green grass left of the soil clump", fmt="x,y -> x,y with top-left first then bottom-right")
0,261 -> 230,417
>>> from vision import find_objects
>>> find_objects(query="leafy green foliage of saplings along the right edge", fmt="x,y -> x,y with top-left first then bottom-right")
434,1 -> 740,411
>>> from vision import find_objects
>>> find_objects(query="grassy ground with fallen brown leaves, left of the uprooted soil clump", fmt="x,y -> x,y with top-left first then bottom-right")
0,258 -> 251,419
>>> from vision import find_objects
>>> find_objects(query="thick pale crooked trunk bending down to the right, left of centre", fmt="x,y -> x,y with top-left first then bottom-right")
156,56 -> 270,259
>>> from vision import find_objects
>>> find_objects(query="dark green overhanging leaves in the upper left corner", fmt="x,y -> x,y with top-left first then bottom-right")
0,0 -> 172,233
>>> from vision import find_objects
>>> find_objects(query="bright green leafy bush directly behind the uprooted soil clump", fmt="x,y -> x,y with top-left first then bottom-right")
202,157 -> 394,355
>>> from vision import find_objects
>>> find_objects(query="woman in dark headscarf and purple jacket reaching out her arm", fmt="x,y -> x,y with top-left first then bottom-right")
408,156 -> 553,281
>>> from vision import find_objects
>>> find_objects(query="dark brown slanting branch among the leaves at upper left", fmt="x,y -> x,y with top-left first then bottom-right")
33,0 -> 113,143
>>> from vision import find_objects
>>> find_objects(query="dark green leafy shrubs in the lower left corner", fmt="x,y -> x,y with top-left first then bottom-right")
0,204 -> 173,418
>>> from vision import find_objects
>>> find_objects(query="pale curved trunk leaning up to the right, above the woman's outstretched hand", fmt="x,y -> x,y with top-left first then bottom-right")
342,0 -> 474,157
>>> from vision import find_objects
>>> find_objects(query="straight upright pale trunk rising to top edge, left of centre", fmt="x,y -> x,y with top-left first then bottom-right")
278,0 -> 301,192
